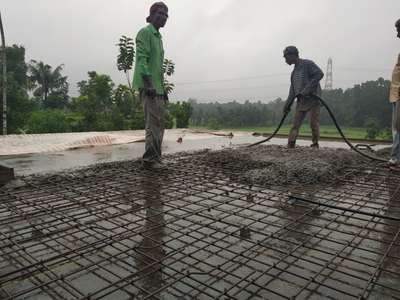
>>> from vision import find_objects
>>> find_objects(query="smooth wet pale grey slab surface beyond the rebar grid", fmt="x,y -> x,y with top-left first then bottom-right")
0,131 -> 390,175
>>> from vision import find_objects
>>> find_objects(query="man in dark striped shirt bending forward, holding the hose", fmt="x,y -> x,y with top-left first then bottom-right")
283,46 -> 324,148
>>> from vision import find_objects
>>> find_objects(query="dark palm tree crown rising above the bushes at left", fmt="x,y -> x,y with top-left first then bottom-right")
29,60 -> 67,102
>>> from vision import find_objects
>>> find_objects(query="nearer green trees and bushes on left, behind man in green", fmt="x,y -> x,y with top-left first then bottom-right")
0,40 -> 192,134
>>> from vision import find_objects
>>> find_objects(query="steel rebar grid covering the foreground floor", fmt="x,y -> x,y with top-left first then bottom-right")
0,153 -> 400,299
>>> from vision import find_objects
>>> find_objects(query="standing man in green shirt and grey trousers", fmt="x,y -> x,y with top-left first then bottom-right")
133,2 -> 168,168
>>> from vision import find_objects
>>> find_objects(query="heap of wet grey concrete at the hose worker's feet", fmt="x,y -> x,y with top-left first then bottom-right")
204,145 -> 371,185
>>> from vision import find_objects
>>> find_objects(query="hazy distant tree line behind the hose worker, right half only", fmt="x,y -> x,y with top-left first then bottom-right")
190,78 -> 391,136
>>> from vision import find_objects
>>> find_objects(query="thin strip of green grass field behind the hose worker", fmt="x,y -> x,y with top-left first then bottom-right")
191,124 -> 387,140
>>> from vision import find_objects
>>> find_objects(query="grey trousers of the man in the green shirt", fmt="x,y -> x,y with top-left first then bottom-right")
140,93 -> 165,162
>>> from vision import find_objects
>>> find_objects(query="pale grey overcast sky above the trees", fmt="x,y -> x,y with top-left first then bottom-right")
0,0 -> 400,101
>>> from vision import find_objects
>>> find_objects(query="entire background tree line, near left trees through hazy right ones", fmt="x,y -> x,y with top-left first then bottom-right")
0,42 -> 391,137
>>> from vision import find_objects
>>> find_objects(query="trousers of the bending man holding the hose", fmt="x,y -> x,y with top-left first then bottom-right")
288,105 -> 321,144
